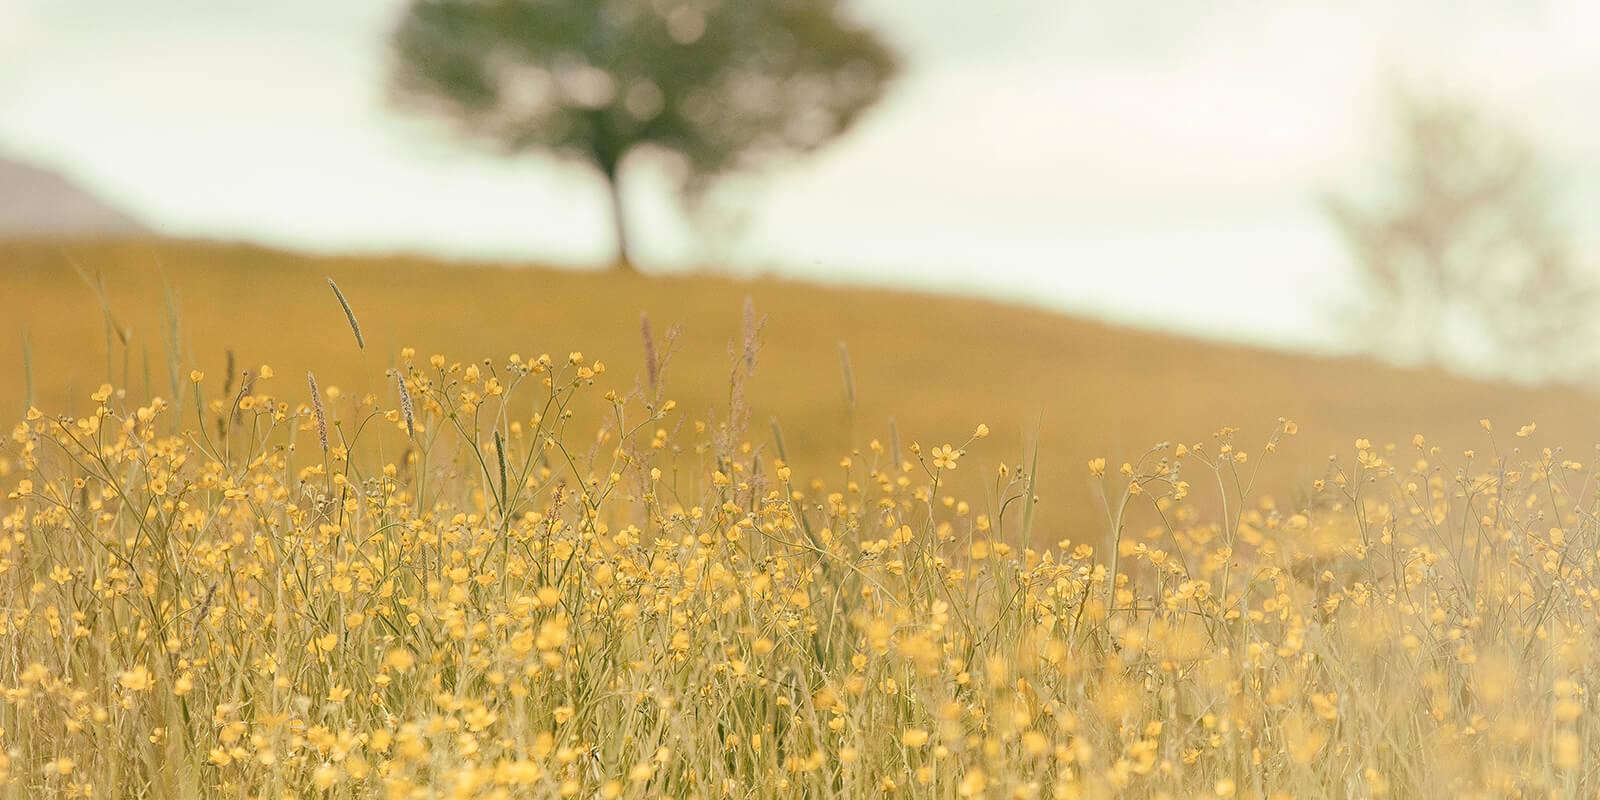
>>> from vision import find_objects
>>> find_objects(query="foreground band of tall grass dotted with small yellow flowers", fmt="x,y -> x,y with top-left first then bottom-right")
0,299 -> 1600,798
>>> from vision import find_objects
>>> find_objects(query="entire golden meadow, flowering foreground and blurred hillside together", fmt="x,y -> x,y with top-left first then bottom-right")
0,243 -> 1600,798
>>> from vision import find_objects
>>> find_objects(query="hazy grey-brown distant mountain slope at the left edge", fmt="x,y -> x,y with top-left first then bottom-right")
0,158 -> 146,237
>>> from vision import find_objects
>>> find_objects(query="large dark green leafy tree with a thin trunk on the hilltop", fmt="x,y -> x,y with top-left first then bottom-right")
390,0 -> 896,269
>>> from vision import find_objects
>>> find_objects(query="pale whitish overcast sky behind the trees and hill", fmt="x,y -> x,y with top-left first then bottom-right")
0,0 -> 1600,350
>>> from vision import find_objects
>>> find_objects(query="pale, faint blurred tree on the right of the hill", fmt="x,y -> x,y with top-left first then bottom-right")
1325,91 -> 1600,381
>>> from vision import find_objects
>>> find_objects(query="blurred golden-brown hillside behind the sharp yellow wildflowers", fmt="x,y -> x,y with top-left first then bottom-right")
0,242 -> 1600,539
